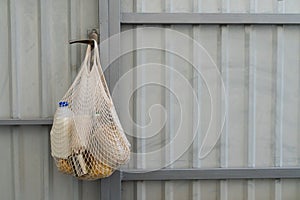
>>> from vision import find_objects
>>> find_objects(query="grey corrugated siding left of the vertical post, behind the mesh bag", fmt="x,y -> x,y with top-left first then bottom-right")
0,0 -> 100,200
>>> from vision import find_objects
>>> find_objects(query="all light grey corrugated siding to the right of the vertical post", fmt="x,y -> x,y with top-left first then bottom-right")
119,0 -> 300,200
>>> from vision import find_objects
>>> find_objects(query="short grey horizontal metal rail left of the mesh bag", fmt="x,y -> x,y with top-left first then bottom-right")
0,118 -> 53,126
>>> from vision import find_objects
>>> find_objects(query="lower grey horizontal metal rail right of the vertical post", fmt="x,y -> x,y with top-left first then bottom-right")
122,168 -> 300,181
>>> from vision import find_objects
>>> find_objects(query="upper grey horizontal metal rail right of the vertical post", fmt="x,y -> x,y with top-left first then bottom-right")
121,13 -> 300,25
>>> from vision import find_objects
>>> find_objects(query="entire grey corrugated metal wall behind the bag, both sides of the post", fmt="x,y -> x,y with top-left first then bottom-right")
0,0 -> 300,200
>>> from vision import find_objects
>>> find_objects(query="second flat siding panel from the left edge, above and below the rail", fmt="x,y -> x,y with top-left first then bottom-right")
7,1 -> 43,199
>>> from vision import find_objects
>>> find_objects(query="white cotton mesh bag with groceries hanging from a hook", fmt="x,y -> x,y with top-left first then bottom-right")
50,41 -> 130,180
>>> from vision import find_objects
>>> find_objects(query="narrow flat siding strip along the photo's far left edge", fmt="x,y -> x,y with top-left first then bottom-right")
0,1 -> 14,200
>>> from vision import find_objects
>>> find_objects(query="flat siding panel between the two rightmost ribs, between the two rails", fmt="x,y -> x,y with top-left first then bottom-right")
255,26 -> 276,166
